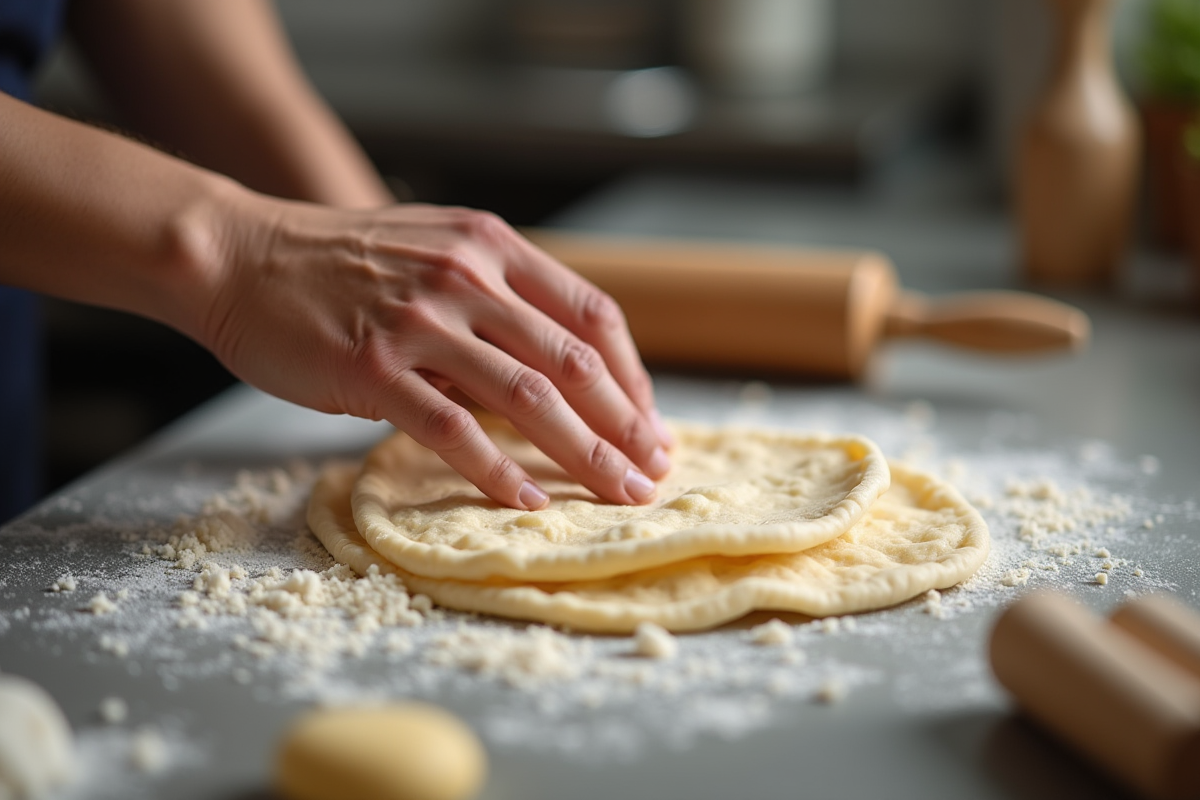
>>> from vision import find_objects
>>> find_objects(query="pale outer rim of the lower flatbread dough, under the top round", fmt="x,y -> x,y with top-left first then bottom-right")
308,464 -> 990,633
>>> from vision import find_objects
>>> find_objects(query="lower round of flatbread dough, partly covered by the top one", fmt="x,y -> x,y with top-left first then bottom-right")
308,464 -> 990,633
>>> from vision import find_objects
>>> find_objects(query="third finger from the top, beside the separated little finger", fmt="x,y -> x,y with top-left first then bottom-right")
437,339 -> 654,504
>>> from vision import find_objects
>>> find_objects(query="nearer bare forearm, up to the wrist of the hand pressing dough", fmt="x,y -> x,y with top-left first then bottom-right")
0,94 -> 236,337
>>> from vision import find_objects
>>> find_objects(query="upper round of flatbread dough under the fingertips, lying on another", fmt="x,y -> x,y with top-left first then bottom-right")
352,422 -> 889,581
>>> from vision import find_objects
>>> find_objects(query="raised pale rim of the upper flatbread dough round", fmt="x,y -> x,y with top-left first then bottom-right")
352,429 -> 892,582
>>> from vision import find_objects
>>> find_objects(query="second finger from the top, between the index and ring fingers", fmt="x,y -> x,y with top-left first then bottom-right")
478,297 -> 671,479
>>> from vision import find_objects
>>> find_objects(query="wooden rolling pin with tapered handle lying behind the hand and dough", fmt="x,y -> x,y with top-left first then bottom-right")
524,229 -> 1091,378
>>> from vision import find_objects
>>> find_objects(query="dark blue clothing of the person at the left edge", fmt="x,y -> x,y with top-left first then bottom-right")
0,0 -> 66,523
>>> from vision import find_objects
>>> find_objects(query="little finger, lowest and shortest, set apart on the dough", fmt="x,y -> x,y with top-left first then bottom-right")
388,372 -> 550,511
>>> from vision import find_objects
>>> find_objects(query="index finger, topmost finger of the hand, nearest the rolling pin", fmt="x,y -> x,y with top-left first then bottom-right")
506,239 -> 672,447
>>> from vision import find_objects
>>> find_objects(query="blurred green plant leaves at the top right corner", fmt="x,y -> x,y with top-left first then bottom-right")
1141,0 -> 1200,101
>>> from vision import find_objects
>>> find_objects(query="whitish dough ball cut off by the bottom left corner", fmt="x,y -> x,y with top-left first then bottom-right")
0,675 -> 74,800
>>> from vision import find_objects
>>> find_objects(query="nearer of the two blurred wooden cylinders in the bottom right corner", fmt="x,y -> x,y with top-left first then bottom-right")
990,593 -> 1200,800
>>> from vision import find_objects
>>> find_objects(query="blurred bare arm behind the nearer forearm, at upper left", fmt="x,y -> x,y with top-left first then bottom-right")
70,0 -> 394,207
